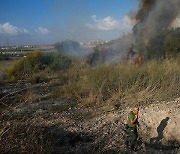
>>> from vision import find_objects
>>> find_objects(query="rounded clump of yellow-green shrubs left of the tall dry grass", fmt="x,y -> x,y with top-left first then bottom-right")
7,51 -> 72,80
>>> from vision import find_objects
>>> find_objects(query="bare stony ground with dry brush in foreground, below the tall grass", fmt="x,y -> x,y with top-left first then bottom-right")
0,79 -> 180,154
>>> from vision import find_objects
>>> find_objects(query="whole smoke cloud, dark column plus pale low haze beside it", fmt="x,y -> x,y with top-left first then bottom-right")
87,0 -> 180,63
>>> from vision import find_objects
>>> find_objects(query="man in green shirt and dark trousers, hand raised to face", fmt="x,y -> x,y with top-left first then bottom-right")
127,106 -> 139,151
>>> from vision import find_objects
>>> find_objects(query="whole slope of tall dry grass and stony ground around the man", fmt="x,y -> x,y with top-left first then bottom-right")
0,52 -> 180,154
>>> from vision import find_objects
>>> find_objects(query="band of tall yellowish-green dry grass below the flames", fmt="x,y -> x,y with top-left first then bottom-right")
56,57 -> 180,105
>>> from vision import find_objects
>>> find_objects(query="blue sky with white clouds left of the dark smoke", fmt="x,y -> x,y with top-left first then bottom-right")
0,0 -> 138,45
